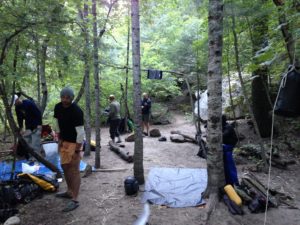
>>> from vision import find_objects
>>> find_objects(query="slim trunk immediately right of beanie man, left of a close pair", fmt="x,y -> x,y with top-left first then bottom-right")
83,0 -> 91,156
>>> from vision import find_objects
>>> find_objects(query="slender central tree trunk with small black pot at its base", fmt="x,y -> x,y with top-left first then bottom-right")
131,0 -> 145,185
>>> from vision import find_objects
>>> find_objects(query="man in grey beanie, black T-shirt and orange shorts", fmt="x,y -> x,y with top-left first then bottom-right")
54,87 -> 84,212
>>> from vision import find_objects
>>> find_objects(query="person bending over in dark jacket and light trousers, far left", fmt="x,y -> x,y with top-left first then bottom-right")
14,95 -> 42,154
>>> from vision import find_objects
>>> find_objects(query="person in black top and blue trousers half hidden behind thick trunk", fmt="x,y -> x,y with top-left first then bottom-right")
222,115 -> 239,185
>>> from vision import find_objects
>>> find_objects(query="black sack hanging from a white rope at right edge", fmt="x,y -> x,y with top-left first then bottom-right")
274,69 -> 300,117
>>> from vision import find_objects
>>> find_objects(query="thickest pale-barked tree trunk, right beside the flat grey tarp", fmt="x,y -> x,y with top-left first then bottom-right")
204,0 -> 225,219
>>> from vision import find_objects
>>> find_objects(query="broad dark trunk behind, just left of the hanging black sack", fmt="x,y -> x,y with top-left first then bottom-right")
251,0 -> 272,137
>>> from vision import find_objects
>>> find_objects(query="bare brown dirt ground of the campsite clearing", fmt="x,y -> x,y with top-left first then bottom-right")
13,114 -> 300,225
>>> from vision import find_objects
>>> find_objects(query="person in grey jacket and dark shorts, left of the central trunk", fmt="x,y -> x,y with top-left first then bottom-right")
108,95 -> 122,143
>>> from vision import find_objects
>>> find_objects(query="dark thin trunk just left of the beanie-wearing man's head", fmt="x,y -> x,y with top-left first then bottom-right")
40,38 -> 49,115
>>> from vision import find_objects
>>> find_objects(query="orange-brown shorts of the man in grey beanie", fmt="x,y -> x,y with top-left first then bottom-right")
59,141 -> 81,165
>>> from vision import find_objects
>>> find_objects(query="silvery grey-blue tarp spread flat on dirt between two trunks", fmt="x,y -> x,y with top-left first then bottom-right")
142,168 -> 207,207
